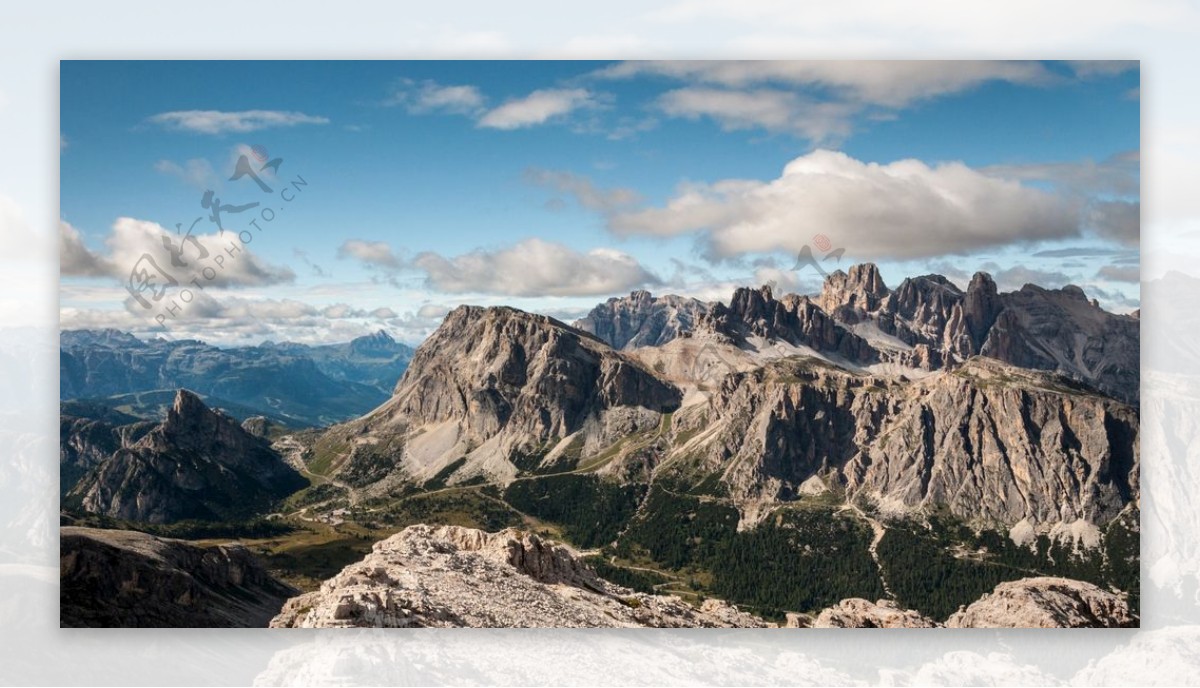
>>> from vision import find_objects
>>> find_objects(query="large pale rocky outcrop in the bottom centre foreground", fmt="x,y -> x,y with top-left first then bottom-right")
271,525 -> 767,628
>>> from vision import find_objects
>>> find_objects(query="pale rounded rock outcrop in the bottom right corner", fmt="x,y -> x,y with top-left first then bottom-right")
946,578 -> 1138,628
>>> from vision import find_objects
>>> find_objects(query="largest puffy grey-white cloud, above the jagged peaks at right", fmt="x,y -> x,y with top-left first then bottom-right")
608,150 -> 1080,259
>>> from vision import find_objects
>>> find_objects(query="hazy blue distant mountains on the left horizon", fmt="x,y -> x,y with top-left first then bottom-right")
59,330 -> 413,426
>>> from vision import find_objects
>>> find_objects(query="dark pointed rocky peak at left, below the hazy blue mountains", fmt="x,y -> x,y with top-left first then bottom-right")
67,390 -> 306,524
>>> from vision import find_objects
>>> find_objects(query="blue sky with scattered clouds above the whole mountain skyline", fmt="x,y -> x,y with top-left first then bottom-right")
60,61 -> 1140,343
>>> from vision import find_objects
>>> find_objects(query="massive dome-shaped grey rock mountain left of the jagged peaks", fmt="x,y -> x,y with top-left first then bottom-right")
317,306 -> 682,485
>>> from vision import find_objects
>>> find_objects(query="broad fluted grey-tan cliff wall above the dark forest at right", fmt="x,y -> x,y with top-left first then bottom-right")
680,359 -> 1138,526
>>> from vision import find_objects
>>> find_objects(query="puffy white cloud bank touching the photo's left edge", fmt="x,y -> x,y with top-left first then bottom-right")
59,217 -> 295,288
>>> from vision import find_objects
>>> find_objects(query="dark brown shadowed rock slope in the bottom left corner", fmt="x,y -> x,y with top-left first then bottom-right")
60,527 -> 298,628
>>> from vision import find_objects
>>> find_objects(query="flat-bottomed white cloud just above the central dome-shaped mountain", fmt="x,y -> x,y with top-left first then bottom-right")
413,239 -> 660,297
